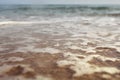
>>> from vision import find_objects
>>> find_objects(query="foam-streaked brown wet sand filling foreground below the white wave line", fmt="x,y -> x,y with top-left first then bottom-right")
0,20 -> 120,80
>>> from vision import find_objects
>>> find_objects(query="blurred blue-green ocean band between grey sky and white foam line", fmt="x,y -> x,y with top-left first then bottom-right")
0,5 -> 120,21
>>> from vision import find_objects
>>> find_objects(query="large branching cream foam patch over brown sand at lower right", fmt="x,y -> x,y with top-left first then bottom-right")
57,53 -> 120,77
